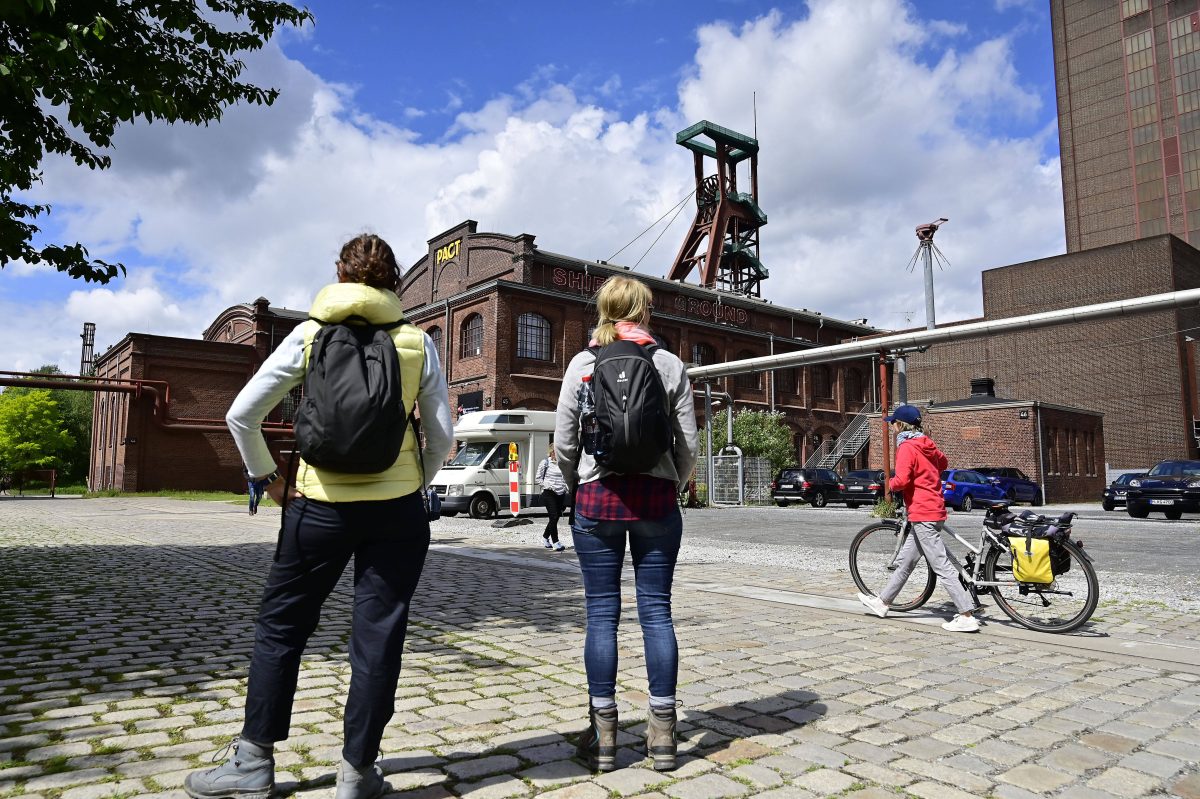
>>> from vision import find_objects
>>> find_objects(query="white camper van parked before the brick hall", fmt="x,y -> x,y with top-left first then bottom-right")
432,409 -> 554,518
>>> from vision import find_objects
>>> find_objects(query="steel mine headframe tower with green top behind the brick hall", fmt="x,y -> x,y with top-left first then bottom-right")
667,120 -> 767,296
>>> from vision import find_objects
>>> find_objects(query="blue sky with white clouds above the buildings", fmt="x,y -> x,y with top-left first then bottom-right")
0,0 -> 1066,373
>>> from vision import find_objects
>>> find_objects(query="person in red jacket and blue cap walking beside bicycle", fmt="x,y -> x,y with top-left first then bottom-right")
858,405 -> 979,632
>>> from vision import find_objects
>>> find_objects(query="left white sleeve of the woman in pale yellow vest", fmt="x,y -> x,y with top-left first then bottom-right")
226,325 -> 304,477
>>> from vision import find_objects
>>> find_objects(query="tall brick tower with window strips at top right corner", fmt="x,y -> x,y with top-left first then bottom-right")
1050,0 -> 1200,252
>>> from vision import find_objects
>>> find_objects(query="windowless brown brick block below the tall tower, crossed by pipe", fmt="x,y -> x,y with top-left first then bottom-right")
908,235 -> 1200,469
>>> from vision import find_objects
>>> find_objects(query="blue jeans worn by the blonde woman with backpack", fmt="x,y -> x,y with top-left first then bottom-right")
571,509 -> 683,697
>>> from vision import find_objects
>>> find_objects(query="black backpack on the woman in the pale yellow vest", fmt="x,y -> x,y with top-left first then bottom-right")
295,317 -> 408,474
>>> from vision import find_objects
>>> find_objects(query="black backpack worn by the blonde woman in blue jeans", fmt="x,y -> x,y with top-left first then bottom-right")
590,341 -> 674,474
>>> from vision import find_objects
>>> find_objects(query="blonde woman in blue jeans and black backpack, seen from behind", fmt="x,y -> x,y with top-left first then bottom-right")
554,276 -> 698,771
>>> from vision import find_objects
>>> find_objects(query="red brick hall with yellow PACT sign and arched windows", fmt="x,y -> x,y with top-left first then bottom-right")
401,220 -> 877,465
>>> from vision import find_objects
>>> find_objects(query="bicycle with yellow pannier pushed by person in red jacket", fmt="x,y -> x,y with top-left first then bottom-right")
850,501 -> 1099,632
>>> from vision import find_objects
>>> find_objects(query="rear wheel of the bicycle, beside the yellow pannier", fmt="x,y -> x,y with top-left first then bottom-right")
984,541 -> 1100,632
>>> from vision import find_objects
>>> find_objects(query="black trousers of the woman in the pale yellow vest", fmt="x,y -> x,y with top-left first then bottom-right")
242,492 -> 430,768
